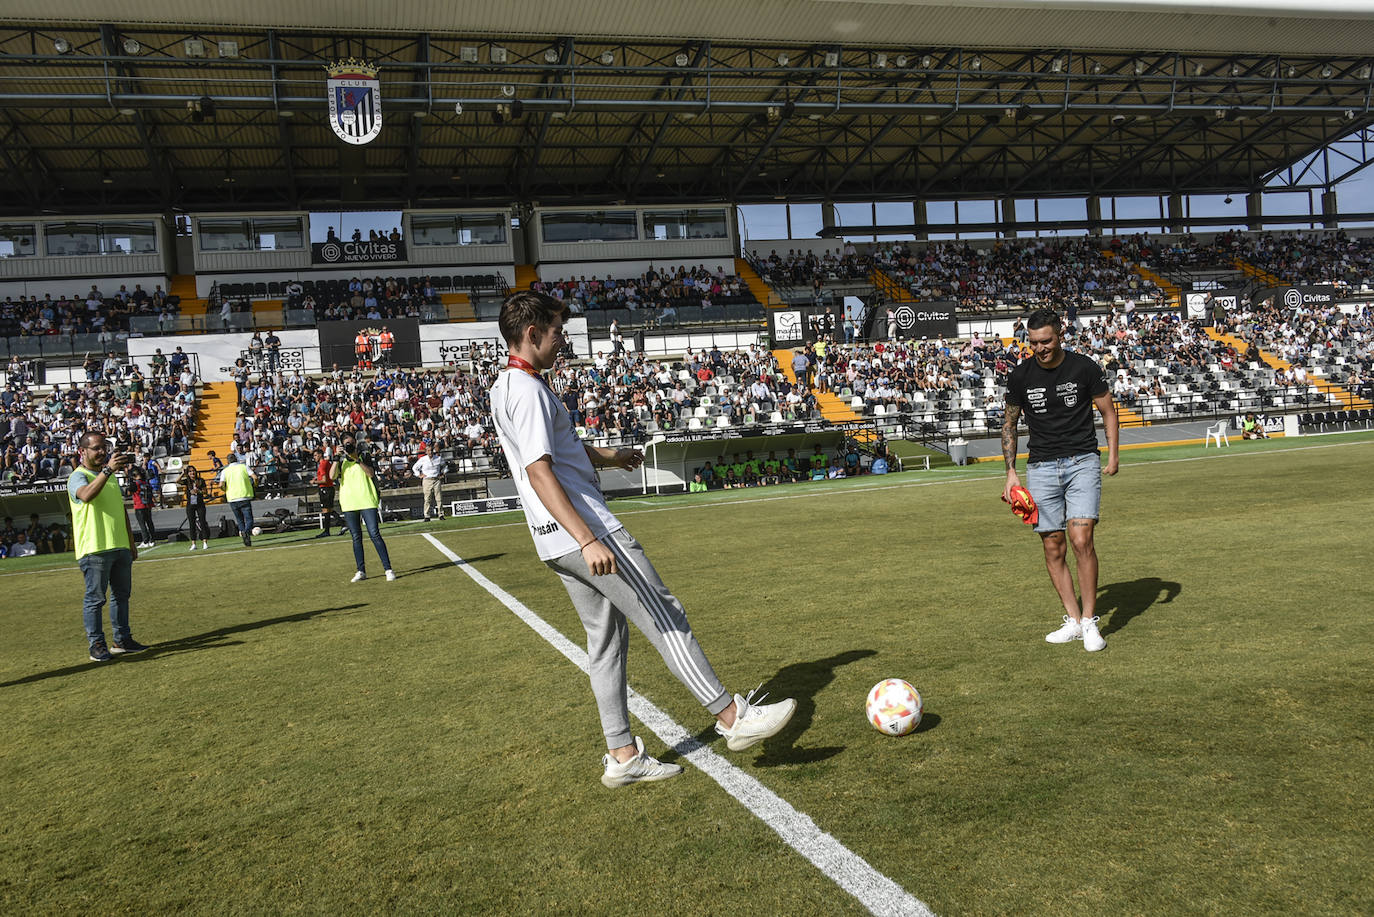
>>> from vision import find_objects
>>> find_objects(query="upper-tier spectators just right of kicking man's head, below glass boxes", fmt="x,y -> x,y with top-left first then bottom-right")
530,264 -> 757,319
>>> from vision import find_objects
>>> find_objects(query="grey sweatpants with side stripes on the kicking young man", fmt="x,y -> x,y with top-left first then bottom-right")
545,529 -> 734,748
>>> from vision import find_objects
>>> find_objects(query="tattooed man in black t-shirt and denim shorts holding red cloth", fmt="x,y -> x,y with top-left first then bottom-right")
1002,309 -> 1118,652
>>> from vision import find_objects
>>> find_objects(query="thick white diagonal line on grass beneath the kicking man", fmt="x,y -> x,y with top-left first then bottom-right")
423,532 -> 934,917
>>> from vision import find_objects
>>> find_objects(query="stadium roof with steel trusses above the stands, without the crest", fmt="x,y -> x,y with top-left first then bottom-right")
0,0 -> 1374,214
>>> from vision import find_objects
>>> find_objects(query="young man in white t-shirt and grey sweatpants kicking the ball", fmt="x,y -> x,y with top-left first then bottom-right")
491,290 -> 797,788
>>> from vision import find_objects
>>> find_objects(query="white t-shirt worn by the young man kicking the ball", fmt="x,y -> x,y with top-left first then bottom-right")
491,370 -> 622,561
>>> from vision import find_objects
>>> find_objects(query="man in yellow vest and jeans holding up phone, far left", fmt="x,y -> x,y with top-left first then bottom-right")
67,433 -> 147,663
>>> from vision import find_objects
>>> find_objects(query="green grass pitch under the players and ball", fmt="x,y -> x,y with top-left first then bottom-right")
0,434 -> 1374,916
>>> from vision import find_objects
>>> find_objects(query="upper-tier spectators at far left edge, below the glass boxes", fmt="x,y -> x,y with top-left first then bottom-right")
0,283 -> 180,341
